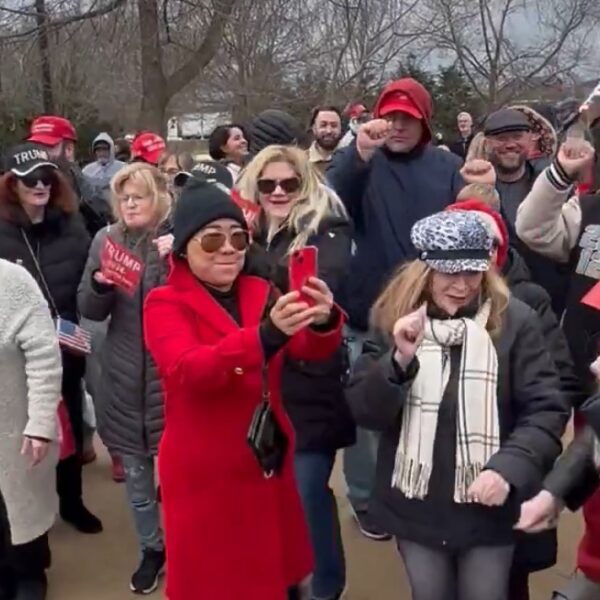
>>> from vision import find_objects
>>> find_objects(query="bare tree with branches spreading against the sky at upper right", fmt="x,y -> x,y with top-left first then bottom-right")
422,0 -> 598,108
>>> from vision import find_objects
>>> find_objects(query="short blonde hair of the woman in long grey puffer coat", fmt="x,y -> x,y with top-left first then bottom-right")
110,162 -> 171,224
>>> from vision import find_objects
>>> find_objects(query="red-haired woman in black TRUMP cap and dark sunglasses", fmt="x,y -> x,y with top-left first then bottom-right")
0,143 -> 102,534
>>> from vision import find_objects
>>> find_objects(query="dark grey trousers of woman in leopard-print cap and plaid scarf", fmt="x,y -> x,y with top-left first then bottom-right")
397,540 -> 514,600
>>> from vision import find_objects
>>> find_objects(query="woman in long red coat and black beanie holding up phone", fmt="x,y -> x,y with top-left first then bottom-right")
144,181 -> 342,600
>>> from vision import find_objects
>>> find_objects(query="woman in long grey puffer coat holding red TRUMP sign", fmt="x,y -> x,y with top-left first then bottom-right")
79,163 -> 172,593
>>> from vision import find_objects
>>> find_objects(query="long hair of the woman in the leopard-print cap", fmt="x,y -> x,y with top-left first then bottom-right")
371,259 -> 509,338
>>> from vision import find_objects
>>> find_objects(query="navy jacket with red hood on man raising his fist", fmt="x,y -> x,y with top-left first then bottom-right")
326,79 -> 464,331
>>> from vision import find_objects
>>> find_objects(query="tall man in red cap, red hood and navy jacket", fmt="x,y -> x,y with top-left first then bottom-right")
326,78 -> 463,540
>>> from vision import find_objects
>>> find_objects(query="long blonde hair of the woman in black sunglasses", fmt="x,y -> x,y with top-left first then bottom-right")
236,146 -> 348,253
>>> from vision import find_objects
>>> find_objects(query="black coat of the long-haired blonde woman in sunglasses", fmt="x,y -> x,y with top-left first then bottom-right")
252,217 -> 356,452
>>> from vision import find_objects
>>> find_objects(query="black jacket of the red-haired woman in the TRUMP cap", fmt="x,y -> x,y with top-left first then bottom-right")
0,205 -> 90,322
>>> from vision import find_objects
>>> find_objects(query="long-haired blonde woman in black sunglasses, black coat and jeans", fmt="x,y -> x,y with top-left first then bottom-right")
239,146 -> 355,600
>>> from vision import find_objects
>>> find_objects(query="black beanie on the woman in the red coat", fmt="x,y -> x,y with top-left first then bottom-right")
173,178 -> 247,256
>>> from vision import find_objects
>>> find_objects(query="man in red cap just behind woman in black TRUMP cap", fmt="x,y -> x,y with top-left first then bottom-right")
27,115 -> 113,237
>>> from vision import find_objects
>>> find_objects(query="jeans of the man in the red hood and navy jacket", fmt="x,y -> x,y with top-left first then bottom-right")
344,328 -> 379,512
